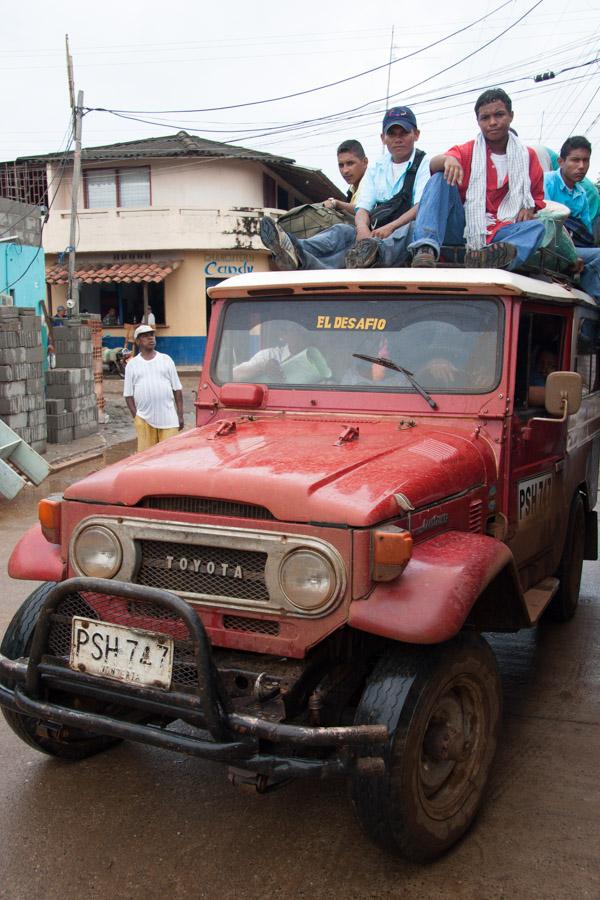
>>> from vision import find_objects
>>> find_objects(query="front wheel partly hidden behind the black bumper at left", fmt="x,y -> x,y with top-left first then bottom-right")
0,582 -> 119,760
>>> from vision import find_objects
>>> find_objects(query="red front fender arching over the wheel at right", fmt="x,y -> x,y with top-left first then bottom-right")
348,531 -> 530,644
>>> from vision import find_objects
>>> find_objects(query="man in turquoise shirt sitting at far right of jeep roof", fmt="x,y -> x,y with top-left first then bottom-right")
544,135 -> 600,302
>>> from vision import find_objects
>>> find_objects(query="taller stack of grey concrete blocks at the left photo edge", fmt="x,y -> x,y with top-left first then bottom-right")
0,306 -> 46,453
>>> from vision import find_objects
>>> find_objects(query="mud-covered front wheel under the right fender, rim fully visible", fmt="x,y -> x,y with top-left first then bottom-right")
352,634 -> 502,862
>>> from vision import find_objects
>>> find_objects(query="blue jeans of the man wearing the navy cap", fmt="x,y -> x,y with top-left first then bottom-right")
290,225 -> 410,269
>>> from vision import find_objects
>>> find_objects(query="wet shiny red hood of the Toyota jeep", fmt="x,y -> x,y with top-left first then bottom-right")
65,415 -> 493,526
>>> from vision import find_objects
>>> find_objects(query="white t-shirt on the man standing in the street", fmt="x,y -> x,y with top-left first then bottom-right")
123,351 -> 182,428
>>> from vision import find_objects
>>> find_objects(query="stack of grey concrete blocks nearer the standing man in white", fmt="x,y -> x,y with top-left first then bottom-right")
46,322 -> 98,444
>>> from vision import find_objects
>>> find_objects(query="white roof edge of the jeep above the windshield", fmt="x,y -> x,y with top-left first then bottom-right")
208,268 -> 596,307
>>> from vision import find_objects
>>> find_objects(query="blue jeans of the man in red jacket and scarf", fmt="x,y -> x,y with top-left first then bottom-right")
408,172 -> 545,269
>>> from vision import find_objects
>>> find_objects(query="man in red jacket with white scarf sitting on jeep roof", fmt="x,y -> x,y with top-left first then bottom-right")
409,88 -> 545,269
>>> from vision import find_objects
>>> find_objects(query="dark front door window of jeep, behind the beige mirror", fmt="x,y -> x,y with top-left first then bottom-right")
515,312 -> 565,415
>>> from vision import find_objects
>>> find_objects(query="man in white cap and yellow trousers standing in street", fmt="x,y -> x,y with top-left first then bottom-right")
123,325 -> 183,452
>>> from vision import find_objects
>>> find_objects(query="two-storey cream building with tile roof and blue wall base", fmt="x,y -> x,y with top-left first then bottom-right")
0,131 -> 343,365
